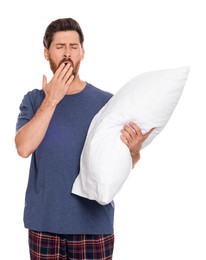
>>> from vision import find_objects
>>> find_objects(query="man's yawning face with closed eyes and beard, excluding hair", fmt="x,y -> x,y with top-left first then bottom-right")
44,31 -> 84,77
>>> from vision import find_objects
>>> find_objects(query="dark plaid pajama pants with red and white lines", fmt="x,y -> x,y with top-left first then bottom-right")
29,230 -> 114,260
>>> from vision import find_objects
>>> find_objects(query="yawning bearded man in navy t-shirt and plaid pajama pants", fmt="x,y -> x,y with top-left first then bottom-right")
15,18 -> 151,260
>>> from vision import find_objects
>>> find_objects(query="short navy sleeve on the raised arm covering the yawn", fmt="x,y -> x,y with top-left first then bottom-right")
16,89 -> 43,132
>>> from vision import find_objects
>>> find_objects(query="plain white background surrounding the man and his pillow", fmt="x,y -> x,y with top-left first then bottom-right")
0,0 -> 206,260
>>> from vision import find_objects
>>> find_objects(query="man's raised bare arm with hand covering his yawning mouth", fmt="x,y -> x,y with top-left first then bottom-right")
15,64 -> 74,158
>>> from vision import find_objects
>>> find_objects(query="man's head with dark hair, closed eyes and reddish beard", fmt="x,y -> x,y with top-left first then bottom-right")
43,18 -> 84,76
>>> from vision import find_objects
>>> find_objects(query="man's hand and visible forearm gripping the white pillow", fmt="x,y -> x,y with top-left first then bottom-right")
120,122 -> 154,168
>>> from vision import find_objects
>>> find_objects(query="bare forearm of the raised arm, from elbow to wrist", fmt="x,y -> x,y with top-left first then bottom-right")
15,98 -> 56,158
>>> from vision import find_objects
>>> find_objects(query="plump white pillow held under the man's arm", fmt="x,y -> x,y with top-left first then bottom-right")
72,66 -> 189,205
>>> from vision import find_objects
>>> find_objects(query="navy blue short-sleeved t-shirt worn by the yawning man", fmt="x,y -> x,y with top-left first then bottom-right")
16,83 -> 114,234
